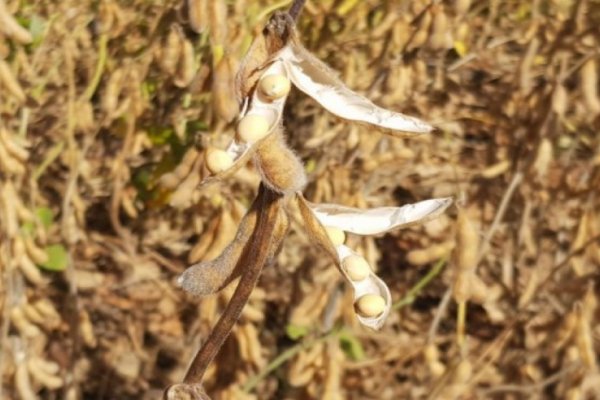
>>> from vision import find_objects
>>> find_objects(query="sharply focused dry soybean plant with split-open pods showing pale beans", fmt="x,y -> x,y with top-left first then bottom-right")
165,0 -> 452,399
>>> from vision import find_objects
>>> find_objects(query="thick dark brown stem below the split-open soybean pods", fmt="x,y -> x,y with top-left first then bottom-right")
183,185 -> 281,384
